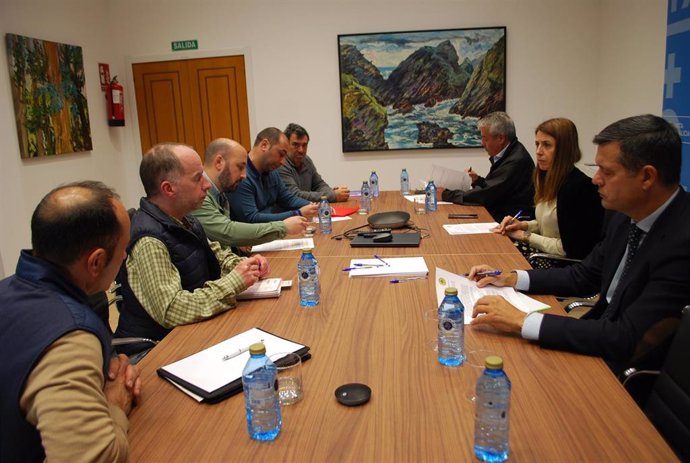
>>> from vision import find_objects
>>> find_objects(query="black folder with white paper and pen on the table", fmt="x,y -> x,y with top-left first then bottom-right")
157,328 -> 311,403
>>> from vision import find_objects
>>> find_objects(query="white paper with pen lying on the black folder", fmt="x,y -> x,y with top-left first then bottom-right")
163,328 -> 304,402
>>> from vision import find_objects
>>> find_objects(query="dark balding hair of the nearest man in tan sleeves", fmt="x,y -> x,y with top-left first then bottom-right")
31,181 -> 122,267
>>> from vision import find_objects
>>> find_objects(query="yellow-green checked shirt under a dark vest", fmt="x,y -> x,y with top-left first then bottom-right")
127,232 -> 247,328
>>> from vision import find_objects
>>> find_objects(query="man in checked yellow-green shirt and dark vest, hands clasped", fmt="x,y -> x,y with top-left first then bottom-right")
115,143 -> 268,355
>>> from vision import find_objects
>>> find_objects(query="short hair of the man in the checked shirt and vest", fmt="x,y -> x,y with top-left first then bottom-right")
139,143 -> 191,198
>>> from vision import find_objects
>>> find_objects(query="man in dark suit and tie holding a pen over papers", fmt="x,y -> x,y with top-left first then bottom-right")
469,115 -> 690,372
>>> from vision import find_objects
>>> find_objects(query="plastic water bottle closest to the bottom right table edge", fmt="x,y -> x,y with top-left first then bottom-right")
474,355 -> 510,462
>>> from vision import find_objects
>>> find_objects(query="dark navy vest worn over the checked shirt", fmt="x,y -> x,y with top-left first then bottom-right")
115,198 -> 220,354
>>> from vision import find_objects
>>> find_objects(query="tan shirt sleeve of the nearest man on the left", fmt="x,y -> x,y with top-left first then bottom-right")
19,330 -> 129,463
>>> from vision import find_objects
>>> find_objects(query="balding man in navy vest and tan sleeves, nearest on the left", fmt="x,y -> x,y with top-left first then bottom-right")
0,181 -> 141,462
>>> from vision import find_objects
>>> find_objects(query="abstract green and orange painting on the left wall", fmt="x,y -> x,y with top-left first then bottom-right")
6,34 -> 92,158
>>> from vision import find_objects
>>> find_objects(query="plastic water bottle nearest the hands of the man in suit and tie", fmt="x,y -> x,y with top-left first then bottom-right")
438,288 -> 465,367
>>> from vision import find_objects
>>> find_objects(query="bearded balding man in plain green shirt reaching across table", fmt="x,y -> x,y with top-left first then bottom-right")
192,138 -> 307,248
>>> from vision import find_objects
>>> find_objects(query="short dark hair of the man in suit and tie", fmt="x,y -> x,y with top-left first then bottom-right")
593,114 -> 683,186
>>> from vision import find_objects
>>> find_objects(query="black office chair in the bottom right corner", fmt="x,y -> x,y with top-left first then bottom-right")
623,305 -> 690,461
